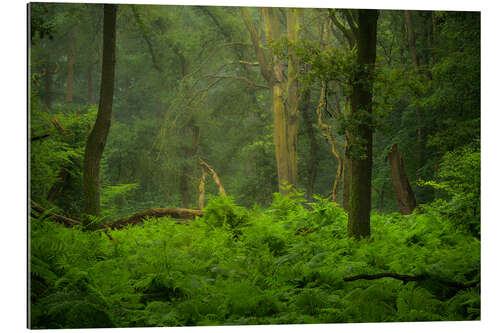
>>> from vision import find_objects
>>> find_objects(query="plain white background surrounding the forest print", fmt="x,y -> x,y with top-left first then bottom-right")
0,0 -> 500,333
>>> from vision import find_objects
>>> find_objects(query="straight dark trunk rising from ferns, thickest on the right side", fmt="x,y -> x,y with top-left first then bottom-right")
347,9 -> 378,239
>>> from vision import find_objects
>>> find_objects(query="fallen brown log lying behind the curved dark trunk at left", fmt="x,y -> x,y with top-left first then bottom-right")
30,200 -> 203,230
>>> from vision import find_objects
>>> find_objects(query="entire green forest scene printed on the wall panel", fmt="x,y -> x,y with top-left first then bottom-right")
27,3 -> 481,329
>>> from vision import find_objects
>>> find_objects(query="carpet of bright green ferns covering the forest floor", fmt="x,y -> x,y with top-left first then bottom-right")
30,194 -> 480,328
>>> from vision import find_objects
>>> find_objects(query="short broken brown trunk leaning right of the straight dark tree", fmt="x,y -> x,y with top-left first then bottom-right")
388,143 -> 417,215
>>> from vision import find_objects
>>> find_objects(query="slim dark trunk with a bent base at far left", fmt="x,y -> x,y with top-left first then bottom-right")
83,4 -> 117,216
